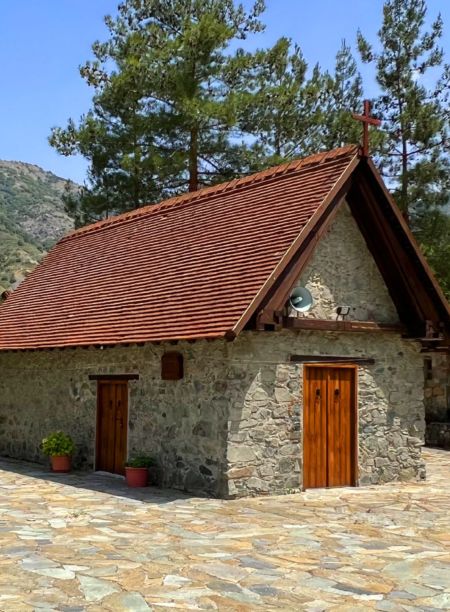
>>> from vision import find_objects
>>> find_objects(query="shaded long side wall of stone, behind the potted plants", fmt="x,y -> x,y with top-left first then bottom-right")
0,342 -> 232,495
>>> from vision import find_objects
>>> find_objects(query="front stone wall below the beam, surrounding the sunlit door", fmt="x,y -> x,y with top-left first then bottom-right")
227,331 -> 425,496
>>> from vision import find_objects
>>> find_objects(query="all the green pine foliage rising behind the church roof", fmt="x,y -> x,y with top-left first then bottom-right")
46,0 -> 450,296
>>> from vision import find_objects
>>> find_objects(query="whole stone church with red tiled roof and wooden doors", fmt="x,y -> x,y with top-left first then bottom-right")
0,147 -> 450,497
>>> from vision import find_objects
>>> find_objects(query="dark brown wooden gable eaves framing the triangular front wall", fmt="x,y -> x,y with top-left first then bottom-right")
255,157 -> 450,350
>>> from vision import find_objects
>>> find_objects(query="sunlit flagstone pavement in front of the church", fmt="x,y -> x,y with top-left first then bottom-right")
0,449 -> 450,612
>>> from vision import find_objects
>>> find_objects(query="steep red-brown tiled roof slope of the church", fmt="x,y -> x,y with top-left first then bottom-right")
0,146 -> 358,350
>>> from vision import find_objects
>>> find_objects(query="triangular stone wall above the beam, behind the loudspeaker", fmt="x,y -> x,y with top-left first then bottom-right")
290,204 -> 398,323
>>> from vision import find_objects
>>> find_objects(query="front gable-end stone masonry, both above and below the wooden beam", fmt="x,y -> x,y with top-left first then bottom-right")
223,203 -> 424,495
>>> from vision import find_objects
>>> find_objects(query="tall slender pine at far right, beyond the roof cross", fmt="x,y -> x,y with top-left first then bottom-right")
358,0 -> 450,220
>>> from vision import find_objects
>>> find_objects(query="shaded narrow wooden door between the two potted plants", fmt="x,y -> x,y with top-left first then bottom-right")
95,380 -> 128,474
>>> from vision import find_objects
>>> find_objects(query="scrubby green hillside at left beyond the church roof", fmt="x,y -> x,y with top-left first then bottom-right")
0,161 -> 76,292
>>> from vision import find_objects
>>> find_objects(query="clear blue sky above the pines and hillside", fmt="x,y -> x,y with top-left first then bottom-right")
0,0 -> 450,182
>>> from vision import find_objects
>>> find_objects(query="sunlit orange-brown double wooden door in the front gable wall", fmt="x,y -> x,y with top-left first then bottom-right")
303,366 -> 357,489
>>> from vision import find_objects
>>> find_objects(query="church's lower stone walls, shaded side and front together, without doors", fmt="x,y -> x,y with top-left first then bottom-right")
0,331 -> 424,496
